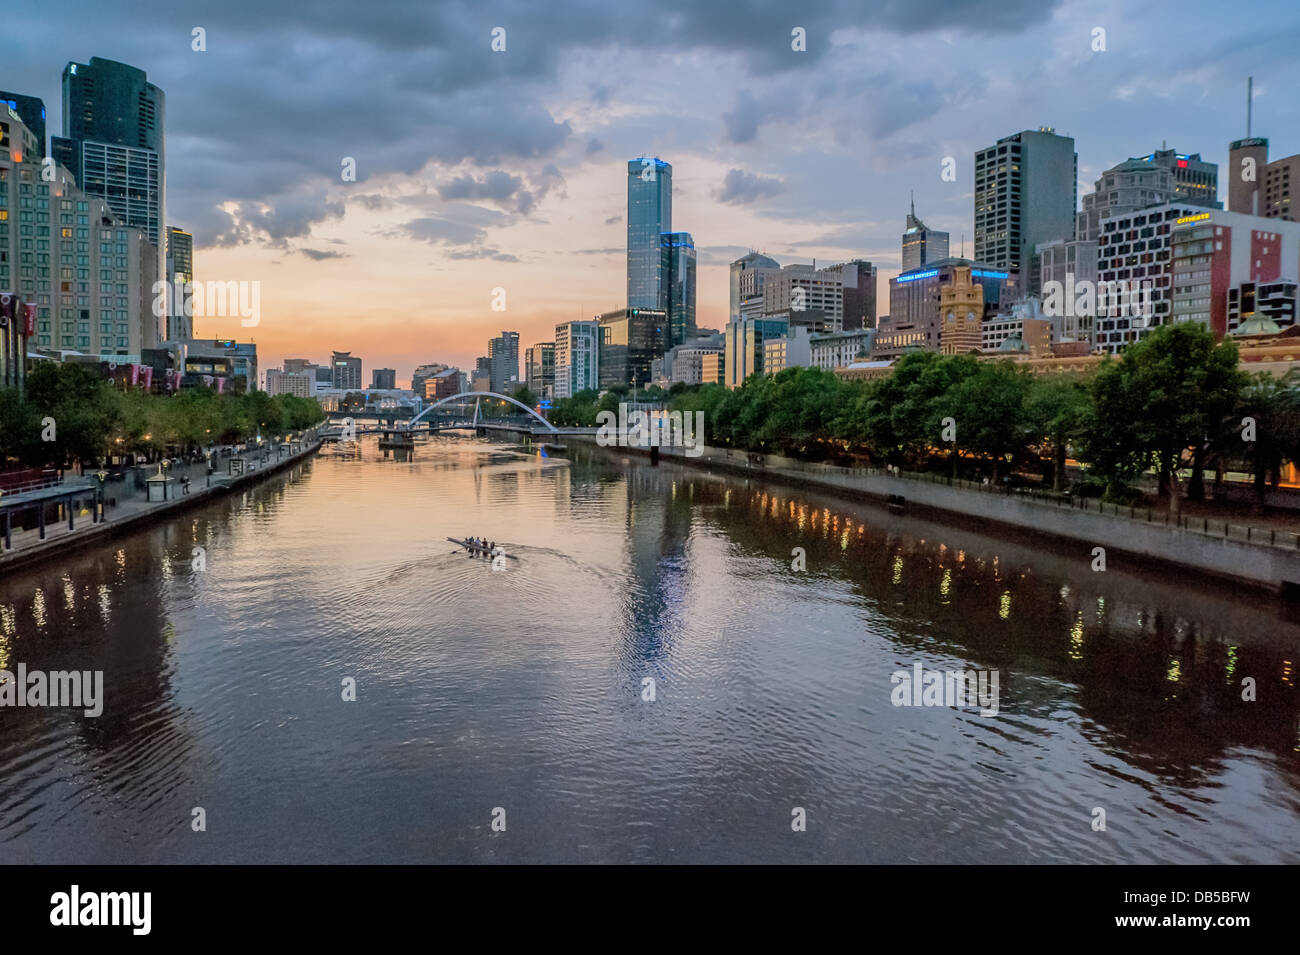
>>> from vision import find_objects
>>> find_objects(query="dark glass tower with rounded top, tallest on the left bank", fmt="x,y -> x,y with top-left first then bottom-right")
51,56 -> 166,274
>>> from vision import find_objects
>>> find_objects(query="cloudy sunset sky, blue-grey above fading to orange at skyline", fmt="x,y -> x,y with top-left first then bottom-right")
0,0 -> 1300,385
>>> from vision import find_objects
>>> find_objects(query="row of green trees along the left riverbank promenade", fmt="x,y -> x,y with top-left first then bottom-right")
0,363 -> 325,468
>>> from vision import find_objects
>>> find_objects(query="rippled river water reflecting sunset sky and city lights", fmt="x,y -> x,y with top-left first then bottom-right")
0,438 -> 1300,863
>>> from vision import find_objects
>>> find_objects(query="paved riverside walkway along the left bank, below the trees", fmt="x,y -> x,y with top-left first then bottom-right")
0,429 -> 321,569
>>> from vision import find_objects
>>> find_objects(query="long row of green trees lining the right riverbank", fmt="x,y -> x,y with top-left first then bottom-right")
551,324 -> 1300,513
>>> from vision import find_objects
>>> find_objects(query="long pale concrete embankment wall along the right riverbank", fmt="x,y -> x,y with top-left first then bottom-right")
566,435 -> 1300,595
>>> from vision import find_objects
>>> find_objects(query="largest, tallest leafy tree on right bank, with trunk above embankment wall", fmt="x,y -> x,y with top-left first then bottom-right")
1087,322 -> 1245,518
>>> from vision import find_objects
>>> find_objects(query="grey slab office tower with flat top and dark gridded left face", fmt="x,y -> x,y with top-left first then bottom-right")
975,126 -> 1079,294
